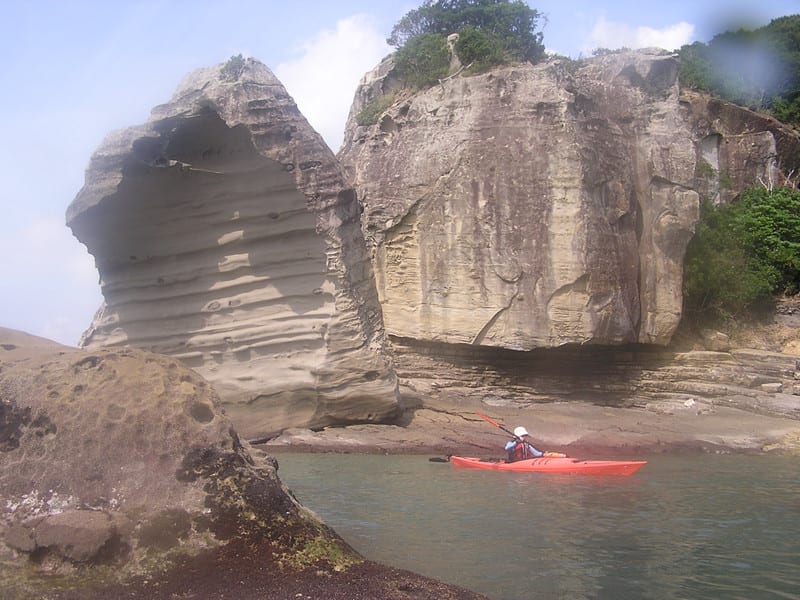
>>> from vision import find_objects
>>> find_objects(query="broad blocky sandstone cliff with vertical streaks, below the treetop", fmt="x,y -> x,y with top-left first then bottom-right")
339,51 -> 800,350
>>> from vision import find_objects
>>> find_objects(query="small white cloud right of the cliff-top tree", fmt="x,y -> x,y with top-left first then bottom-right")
583,17 -> 694,54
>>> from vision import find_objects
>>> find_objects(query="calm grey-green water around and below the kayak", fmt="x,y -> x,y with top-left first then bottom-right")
277,454 -> 800,600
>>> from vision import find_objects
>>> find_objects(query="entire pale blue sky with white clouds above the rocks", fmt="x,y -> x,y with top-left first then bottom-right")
0,0 -> 800,346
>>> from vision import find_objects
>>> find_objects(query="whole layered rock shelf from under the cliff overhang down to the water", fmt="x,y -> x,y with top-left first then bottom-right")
262,308 -> 800,457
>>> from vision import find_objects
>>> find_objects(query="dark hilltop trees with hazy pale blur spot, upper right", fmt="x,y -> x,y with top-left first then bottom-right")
680,15 -> 800,122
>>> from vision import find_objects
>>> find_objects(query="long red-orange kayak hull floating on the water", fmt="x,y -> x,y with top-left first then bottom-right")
450,456 -> 647,475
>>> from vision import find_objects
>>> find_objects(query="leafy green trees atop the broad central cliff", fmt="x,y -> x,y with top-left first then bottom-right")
386,0 -> 544,87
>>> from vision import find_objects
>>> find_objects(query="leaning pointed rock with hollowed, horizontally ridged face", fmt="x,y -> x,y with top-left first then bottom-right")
67,60 -> 397,436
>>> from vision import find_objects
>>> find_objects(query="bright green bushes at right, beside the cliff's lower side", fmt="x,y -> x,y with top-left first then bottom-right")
683,188 -> 800,319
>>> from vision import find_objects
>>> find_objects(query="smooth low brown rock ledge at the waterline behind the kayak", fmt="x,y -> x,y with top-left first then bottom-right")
256,400 -> 800,457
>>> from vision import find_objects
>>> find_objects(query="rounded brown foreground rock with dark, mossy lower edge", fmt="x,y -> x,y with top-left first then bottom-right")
0,328 -> 479,600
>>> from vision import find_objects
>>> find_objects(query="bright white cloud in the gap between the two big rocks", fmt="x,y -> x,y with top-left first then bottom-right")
275,15 -> 392,152
